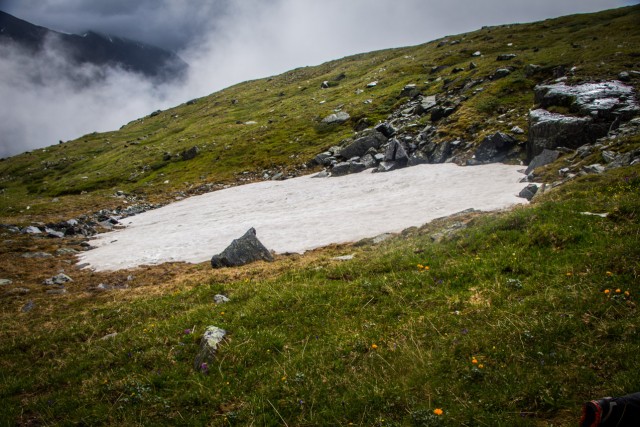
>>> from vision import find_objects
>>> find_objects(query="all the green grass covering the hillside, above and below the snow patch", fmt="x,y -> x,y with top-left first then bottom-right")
0,6 -> 640,426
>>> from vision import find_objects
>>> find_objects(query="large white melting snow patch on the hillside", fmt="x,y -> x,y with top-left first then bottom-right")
79,164 -> 527,270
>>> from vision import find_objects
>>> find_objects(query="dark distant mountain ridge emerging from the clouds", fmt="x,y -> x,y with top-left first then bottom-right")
0,11 -> 187,81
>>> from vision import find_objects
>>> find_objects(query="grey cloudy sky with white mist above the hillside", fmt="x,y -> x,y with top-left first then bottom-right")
0,0 -> 638,157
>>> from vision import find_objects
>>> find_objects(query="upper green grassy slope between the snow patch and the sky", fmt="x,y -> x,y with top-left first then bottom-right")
0,7 -> 640,223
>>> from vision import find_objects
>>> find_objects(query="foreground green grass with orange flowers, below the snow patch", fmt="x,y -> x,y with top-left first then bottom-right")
0,167 -> 640,426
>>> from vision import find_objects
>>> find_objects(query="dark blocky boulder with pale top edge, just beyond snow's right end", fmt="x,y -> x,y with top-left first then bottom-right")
527,109 -> 606,160
